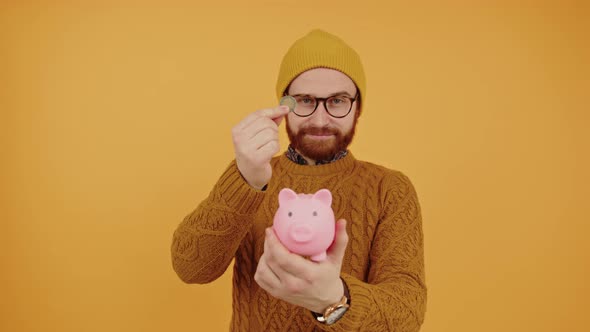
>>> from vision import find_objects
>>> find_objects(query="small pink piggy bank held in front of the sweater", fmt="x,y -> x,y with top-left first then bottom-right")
273,188 -> 336,262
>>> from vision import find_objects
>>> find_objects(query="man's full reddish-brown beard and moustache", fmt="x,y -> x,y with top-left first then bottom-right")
286,117 -> 358,161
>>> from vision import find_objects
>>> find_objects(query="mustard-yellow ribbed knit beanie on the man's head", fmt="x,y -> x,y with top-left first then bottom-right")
277,29 -> 366,114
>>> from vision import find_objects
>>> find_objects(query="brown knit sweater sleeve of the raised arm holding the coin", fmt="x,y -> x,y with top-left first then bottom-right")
171,160 -> 265,284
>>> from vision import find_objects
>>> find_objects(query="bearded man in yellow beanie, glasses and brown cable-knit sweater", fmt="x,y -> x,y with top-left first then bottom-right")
172,30 -> 426,332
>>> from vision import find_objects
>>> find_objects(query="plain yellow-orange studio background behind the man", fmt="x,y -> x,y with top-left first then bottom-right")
0,0 -> 590,332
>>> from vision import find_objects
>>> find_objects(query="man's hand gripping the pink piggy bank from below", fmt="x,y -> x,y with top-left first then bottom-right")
254,219 -> 348,313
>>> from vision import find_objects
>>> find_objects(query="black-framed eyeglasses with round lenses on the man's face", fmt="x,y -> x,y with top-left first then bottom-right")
284,90 -> 359,118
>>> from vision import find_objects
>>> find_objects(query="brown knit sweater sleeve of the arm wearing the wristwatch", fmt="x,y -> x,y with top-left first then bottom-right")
314,173 -> 427,332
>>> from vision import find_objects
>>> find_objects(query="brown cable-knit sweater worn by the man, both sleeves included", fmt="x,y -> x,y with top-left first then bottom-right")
172,153 -> 426,332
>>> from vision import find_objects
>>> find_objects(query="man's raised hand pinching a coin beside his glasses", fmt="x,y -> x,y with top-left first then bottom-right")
232,106 -> 289,189
